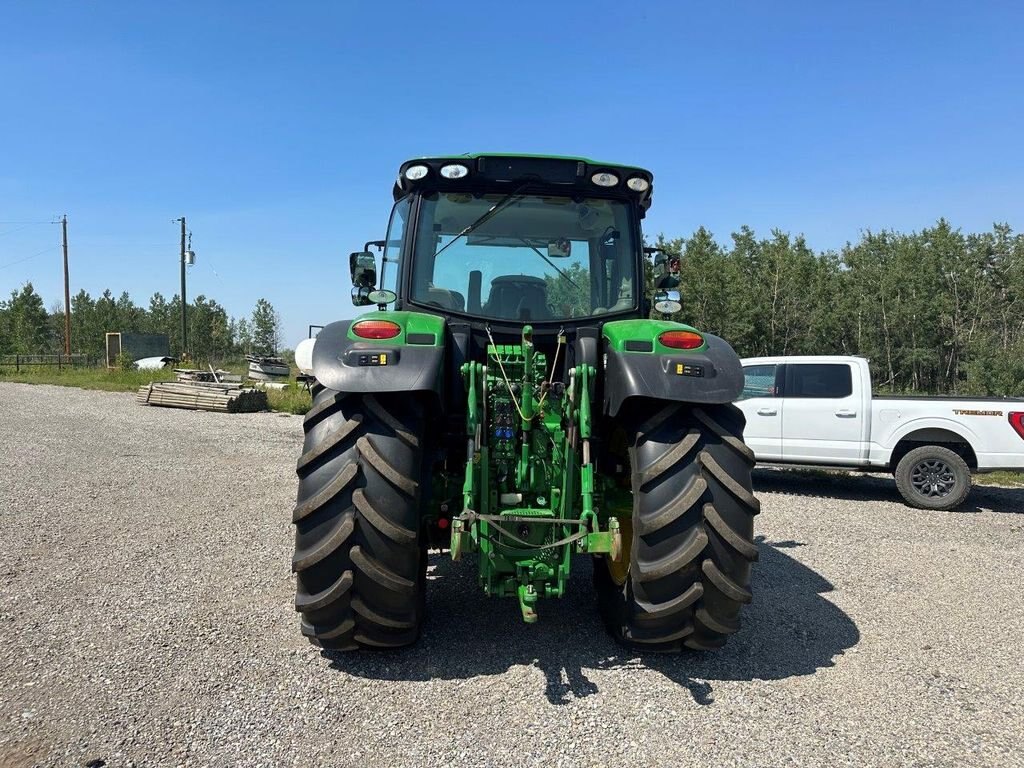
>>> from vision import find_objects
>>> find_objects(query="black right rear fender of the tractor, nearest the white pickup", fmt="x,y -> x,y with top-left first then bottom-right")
604,333 -> 743,417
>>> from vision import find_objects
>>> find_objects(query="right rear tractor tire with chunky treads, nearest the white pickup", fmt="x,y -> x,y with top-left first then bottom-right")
595,400 -> 760,650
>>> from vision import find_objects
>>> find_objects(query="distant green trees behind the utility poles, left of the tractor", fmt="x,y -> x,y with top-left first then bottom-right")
0,283 -> 281,362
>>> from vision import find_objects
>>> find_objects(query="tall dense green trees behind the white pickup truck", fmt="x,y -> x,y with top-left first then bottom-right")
657,219 -> 1024,395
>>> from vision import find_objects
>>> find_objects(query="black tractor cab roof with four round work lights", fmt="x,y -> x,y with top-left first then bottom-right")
394,153 -> 654,210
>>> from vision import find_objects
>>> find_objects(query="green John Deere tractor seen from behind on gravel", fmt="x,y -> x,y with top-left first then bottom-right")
292,155 -> 759,650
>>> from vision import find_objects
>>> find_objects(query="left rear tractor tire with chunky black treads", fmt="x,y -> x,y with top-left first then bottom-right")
292,388 -> 426,650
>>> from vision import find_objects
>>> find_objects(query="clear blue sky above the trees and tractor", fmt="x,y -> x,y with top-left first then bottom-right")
0,0 -> 1024,345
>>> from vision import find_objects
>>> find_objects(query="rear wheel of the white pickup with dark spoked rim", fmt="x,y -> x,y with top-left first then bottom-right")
896,445 -> 971,510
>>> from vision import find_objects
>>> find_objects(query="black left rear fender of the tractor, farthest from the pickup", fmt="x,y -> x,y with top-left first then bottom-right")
312,313 -> 444,397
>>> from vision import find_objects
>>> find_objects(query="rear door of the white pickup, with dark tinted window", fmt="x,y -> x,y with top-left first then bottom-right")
781,362 -> 868,465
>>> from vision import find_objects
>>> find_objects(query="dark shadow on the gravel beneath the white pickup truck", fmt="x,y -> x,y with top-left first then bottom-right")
754,468 -> 1024,515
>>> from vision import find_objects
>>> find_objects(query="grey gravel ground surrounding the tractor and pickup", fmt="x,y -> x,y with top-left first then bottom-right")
0,384 -> 1024,768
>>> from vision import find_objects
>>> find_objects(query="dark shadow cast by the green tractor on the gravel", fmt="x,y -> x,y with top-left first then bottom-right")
322,539 -> 860,705
